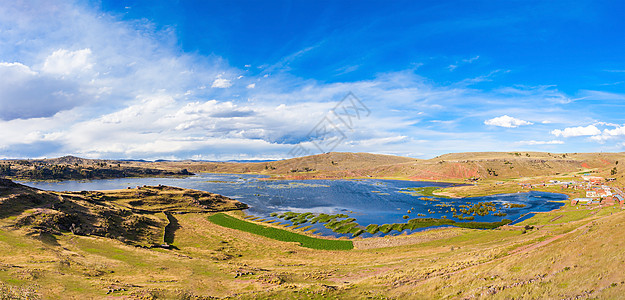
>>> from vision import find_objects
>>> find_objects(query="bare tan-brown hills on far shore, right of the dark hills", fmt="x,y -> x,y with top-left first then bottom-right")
152,152 -> 625,181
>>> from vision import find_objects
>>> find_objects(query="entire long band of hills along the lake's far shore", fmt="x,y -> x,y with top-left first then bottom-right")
0,152 -> 625,184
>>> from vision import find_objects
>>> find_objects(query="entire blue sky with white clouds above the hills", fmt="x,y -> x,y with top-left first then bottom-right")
0,0 -> 625,160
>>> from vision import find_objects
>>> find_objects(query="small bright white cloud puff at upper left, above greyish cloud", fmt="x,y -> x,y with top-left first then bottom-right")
42,49 -> 93,75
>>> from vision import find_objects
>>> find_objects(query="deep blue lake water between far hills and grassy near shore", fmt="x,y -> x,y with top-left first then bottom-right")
21,174 -> 568,237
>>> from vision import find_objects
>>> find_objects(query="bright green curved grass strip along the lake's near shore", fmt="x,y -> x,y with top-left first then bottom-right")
208,213 -> 354,250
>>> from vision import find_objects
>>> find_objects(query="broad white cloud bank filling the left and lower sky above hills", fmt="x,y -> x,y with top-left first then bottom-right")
0,1 -> 612,159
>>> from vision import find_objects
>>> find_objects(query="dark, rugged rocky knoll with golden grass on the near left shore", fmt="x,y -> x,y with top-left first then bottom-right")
0,179 -> 247,247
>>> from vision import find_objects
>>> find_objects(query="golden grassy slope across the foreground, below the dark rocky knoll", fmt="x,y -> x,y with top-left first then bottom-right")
0,195 -> 625,299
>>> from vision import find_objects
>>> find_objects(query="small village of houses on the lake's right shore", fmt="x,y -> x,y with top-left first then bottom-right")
519,173 -> 625,208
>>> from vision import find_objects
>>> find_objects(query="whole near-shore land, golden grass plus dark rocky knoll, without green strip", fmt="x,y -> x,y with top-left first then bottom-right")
0,180 -> 625,299
